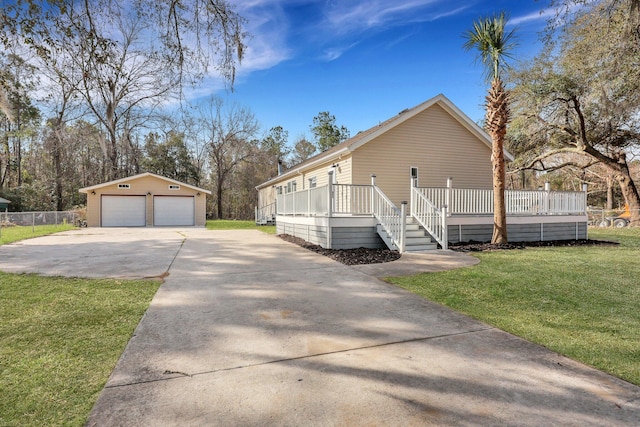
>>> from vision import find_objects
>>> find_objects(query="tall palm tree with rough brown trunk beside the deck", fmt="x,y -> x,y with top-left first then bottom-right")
464,12 -> 516,243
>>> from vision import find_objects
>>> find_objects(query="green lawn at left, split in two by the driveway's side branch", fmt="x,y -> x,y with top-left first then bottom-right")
0,226 -> 160,426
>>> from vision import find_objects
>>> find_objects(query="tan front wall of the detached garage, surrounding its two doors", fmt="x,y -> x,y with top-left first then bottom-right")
87,176 -> 206,227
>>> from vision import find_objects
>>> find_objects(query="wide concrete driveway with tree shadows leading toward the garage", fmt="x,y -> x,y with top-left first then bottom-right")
0,229 -> 640,426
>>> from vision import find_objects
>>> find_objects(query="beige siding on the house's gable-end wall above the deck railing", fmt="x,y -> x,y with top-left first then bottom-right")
353,105 -> 492,204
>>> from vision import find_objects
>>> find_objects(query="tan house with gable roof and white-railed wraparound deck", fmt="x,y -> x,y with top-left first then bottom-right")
256,95 -> 586,250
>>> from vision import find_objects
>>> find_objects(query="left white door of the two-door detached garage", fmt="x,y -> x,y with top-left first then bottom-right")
102,196 -> 147,227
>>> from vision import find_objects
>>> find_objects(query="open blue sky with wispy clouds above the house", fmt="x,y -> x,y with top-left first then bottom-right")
201,0 -> 548,145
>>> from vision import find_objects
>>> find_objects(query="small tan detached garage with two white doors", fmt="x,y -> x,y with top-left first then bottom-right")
79,173 -> 211,227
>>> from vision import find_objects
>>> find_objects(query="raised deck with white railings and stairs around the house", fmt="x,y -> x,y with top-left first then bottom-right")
256,179 -> 588,252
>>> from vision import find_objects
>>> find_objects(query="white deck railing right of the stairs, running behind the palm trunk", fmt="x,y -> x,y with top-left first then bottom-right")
416,187 -> 587,215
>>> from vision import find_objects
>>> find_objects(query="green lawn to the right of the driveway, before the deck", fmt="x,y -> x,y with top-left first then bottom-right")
388,229 -> 640,385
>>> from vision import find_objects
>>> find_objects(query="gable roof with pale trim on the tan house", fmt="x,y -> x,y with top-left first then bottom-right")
256,94 -> 514,189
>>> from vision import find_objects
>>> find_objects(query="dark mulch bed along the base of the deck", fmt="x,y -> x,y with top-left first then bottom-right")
278,234 -> 618,265
